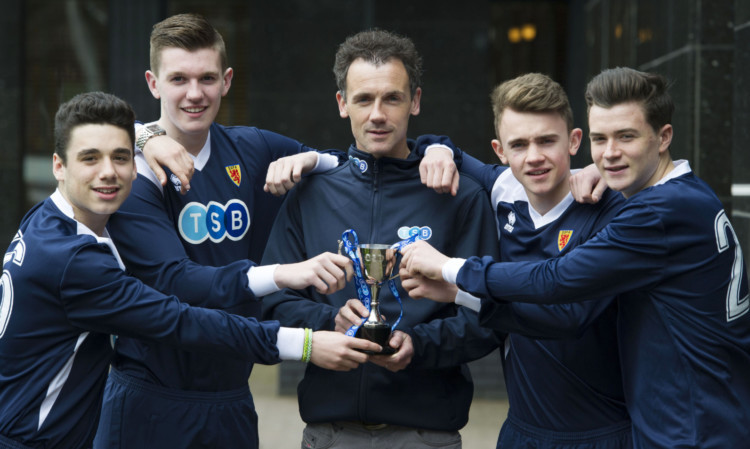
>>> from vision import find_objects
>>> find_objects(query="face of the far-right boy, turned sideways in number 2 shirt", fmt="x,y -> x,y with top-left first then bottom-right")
589,102 -> 672,198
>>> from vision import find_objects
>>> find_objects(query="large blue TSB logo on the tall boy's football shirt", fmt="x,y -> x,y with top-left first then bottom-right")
178,200 -> 250,244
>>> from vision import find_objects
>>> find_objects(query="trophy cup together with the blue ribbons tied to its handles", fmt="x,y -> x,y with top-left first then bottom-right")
339,229 -> 420,353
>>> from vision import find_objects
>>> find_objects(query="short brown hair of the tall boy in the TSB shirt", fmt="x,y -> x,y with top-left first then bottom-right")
150,14 -> 229,75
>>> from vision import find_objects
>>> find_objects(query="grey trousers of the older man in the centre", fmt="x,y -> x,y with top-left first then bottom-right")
302,422 -> 461,449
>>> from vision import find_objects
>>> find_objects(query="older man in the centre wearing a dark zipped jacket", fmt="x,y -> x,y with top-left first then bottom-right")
263,31 -> 497,449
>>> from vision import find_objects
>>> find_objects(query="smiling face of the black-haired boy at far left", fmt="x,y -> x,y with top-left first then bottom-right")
52,124 -> 137,235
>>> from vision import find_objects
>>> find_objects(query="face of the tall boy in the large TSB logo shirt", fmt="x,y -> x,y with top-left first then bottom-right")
146,47 -> 233,149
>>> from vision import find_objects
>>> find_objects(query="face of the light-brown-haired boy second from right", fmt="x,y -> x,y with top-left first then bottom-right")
492,109 -> 582,213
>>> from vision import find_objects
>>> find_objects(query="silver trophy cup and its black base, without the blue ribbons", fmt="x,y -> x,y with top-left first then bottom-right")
356,244 -> 401,354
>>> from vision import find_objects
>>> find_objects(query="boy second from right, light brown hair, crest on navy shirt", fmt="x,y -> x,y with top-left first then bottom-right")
403,73 -> 632,449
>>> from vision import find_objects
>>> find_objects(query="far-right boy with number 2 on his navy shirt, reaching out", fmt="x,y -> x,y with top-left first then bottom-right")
402,68 -> 750,449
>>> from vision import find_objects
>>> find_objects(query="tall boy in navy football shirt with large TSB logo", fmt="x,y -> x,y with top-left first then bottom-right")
95,14 -> 382,449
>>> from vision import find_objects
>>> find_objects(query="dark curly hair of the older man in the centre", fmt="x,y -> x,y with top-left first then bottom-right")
333,29 -> 422,98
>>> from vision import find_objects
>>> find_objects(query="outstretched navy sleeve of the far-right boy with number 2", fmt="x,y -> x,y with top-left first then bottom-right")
457,202 -> 669,304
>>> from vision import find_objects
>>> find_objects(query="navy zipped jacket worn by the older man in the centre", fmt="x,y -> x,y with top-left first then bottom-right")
263,143 -> 496,440
